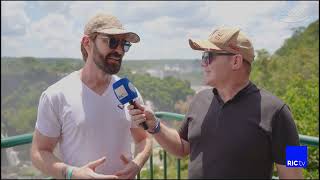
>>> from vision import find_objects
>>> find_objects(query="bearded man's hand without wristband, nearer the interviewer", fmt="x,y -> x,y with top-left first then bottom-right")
115,154 -> 140,179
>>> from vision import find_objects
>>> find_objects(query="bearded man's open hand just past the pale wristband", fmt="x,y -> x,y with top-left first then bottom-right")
71,157 -> 119,179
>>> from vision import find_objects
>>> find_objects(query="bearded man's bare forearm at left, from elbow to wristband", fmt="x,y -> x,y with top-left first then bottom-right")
32,150 -> 67,179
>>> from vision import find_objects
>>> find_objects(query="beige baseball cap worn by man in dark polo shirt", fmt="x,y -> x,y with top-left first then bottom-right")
189,27 -> 254,63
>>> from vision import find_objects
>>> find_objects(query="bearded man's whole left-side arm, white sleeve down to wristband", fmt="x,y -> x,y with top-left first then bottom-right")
31,92 -> 67,179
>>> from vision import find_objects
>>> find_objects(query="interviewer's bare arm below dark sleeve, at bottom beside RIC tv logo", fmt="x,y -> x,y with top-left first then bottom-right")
276,164 -> 303,179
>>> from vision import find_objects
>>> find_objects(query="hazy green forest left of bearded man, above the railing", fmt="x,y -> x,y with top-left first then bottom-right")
1,57 -> 82,136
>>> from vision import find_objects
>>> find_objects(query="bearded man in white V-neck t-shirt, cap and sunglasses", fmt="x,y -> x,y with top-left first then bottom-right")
31,14 -> 152,179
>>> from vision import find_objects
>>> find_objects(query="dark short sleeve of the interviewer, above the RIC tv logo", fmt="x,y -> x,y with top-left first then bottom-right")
272,105 -> 299,165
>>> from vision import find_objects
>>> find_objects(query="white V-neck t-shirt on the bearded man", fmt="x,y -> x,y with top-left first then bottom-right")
36,71 -> 143,174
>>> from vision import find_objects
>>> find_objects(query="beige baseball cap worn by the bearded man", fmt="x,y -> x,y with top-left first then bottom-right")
84,13 -> 140,43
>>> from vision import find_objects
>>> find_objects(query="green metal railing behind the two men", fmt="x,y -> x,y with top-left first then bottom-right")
1,112 -> 319,179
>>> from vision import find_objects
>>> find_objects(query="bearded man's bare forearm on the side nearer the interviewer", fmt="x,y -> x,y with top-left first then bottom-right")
133,136 -> 152,168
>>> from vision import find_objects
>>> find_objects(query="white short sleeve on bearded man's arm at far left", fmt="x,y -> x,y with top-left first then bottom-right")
36,92 -> 62,137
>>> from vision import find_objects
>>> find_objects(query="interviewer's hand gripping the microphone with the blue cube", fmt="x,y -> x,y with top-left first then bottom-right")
128,102 -> 157,131
